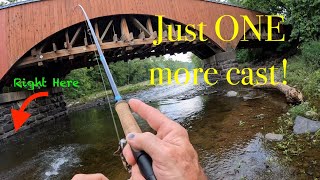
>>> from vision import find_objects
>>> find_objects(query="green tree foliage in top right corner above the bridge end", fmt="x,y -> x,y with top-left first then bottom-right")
229,0 -> 320,42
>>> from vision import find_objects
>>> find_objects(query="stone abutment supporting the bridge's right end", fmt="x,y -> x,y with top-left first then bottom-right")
204,50 -> 239,79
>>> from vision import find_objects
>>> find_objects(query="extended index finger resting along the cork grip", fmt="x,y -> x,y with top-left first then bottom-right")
129,99 -> 178,131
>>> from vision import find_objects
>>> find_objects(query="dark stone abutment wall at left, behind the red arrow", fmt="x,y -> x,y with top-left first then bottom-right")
0,88 -> 67,140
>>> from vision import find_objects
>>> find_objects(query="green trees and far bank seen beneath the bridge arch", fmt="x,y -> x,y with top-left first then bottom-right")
64,55 -> 202,107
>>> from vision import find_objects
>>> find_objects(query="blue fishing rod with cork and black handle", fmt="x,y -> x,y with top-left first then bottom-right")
78,4 -> 157,180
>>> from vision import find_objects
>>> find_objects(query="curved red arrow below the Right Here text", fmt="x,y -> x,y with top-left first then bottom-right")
11,92 -> 49,132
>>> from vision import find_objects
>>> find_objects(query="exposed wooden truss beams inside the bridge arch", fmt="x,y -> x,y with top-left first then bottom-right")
17,15 -> 221,69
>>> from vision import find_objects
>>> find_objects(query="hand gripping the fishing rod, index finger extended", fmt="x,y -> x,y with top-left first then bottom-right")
123,99 -> 207,180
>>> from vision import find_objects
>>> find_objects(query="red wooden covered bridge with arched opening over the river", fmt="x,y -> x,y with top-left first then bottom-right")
0,0 -> 283,90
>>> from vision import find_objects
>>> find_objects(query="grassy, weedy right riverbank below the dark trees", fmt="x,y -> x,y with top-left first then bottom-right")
240,42 -> 320,179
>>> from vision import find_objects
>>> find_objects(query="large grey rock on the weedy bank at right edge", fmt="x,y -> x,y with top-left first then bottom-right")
293,116 -> 320,134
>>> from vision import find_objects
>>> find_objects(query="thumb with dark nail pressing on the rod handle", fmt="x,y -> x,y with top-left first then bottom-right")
127,132 -> 164,160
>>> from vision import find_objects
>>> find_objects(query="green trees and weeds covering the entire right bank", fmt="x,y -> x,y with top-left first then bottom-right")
229,0 -> 320,177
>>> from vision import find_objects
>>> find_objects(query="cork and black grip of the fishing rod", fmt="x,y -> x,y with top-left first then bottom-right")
115,101 -> 157,180
